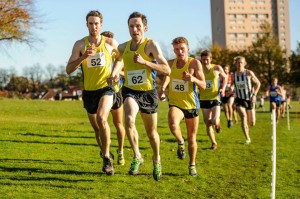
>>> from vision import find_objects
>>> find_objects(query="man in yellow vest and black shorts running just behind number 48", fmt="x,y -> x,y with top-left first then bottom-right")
200,50 -> 227,150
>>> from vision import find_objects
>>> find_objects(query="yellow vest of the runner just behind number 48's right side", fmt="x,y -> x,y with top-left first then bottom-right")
200,64 -> 220,100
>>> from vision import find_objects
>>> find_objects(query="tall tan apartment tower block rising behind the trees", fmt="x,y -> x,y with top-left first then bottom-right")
210,0 -> 291,54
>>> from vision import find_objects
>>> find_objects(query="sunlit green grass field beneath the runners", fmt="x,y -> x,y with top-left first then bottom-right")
0,99 -> 300,199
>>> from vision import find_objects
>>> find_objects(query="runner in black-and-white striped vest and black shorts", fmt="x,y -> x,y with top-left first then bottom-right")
232,56 -> 260,144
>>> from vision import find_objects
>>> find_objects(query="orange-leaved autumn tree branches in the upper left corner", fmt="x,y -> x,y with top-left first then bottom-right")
0,0 -> 37,46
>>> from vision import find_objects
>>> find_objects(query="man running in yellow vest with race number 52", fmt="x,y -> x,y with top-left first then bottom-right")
66,10 -> 119,175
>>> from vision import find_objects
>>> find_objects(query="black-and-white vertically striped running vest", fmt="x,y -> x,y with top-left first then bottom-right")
234,70 -> 252,100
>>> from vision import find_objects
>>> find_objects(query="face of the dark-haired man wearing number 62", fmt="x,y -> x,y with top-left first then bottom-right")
128,18 -> 146,40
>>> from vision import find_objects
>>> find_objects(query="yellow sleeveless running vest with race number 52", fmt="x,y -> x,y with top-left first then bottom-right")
81,36 -> 112,91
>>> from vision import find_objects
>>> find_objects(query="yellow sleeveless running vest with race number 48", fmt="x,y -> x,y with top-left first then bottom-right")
168,57 -> 200,109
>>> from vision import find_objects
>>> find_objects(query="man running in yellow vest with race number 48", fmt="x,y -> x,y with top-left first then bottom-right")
159,37 -> 206,176
